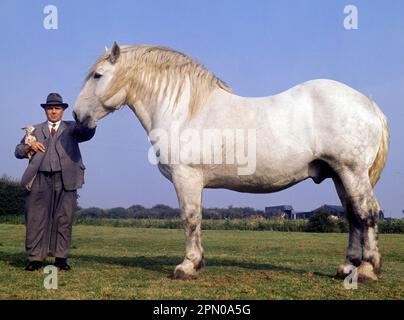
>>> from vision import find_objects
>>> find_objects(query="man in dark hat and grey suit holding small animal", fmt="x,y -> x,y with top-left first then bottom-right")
15,93 -> 95,271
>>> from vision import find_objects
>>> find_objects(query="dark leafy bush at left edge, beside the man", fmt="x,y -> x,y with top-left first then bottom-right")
0,175 -> 27,215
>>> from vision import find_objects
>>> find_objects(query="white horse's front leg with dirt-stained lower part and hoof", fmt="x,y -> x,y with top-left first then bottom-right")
173,171 -> 204,279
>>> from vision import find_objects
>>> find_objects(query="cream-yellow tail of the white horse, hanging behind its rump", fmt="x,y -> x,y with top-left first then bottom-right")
369,101 -> 389,187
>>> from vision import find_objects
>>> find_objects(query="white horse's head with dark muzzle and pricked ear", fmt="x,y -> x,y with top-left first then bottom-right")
73,42 -> 127,128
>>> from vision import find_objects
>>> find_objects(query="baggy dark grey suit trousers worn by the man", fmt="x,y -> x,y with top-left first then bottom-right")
25,171 -> 78,261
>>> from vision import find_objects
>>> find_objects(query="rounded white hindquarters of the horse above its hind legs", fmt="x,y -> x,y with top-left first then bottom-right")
286,79 -> 382,170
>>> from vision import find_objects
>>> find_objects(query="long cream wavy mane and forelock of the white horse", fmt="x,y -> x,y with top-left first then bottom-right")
86,45 -> 231,115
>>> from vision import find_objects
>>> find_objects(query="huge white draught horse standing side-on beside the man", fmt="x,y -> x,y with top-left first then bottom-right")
73,43 -> 389,280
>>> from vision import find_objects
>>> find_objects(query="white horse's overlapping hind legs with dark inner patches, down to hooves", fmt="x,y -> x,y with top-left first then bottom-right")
334,171 -> 381,280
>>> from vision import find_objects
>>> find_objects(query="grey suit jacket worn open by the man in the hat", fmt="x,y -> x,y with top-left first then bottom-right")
15,121 -> 95,191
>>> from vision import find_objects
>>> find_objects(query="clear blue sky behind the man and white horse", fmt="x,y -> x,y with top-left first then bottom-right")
0,0 -> 404,217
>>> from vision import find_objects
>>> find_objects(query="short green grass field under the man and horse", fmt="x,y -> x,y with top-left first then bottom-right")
0,224 -> 404,299
